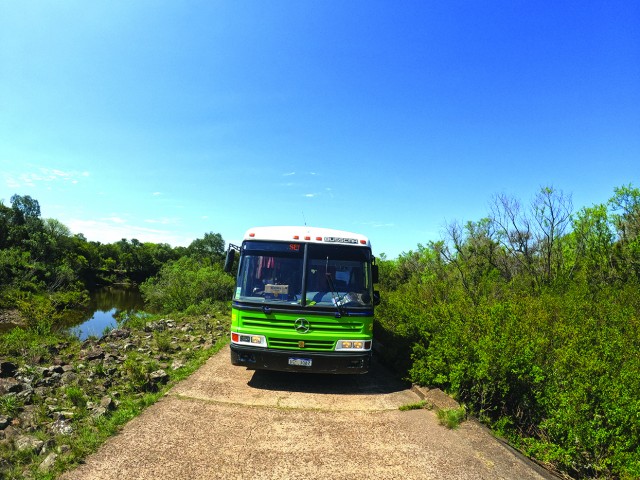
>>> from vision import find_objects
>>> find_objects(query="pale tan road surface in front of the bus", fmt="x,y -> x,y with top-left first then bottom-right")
62,347 -> 555,480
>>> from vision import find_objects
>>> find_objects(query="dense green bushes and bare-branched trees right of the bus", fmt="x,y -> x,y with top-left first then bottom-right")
376,185 -> 640,478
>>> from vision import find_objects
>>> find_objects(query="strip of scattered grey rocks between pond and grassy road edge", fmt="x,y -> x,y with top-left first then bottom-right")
0,316 -> 228,478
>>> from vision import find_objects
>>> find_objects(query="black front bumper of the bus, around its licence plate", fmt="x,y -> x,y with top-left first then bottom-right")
231,343 -> 371,374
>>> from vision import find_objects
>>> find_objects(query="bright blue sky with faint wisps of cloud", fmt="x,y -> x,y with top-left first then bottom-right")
0,0 -> 640,258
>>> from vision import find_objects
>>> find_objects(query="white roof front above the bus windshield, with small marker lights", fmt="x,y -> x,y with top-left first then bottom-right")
244,226 -> 371,248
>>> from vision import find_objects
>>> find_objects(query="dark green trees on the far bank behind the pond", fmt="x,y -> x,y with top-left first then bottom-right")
0,195 -> 230,319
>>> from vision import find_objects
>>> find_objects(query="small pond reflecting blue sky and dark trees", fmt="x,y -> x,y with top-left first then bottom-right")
65,287 -> 144,340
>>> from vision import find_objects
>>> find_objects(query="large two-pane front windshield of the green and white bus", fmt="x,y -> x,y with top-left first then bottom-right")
234,240 -> 373,310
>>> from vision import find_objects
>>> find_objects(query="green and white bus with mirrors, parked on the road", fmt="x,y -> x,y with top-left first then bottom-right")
225,226 -> 379,373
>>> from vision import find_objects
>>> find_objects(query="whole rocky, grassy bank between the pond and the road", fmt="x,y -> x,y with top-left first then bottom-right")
0,309 -> 229,479
